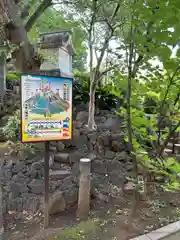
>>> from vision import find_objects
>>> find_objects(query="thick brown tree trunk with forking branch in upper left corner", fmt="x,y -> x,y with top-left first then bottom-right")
0,0 -> 54,71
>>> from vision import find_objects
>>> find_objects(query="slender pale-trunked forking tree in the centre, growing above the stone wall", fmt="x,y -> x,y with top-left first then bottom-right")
65,0 -> 121,129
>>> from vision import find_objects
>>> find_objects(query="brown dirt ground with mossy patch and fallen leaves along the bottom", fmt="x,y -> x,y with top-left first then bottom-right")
5,189 -> 180,240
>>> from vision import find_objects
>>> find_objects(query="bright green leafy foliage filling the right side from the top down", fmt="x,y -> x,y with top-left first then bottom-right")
107,0 -> 180,190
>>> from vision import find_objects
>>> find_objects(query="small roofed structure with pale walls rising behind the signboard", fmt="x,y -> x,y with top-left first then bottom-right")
38,29 -> 75,77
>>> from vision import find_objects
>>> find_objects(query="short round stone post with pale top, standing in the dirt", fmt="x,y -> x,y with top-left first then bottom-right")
77,158 -> 91,219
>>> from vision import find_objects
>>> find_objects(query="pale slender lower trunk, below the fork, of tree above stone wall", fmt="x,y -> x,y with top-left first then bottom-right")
88,81 -> 96,130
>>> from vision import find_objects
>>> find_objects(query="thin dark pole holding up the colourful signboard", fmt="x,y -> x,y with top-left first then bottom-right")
44,142 -> 50,228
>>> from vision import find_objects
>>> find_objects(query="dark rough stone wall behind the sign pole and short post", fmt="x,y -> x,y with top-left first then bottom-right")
0,102 -> 132,213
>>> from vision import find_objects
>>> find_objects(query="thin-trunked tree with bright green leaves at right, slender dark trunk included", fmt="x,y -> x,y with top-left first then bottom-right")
112,0 -> 180,216
